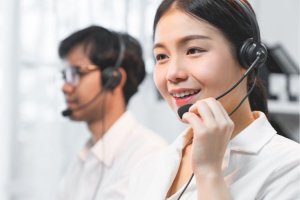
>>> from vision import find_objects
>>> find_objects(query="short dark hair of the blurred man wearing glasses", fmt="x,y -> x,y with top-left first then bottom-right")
58,26 -> 146,105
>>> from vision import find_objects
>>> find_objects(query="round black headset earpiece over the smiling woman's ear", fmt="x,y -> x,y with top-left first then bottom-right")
240,38 -> 268,68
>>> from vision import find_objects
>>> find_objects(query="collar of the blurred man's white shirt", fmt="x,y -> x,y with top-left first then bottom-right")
79,111 -> 137,166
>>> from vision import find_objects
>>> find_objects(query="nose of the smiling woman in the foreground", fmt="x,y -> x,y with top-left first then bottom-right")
166,58 -> 188,83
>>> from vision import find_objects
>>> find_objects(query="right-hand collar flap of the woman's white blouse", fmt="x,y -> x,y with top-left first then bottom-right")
230,111 -> 276,154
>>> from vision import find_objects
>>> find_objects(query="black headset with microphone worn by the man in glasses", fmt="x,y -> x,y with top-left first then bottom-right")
62,33 -> 126,117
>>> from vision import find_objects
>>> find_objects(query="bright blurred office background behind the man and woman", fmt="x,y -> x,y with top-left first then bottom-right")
0,0 -> 300,200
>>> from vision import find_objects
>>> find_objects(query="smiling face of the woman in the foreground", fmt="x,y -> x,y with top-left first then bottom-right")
153,8 -> 246,115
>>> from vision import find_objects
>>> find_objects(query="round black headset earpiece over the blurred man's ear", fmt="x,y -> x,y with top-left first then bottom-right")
101,67 -> 122,90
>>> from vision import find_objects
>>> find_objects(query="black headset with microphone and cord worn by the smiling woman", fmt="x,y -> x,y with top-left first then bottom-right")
177,0 -> 268,200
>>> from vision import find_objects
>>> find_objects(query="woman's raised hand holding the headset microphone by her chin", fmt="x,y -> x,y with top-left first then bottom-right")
183,98 -> 234,176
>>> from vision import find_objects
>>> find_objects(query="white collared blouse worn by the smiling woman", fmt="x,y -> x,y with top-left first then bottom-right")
126,112 -> 300,200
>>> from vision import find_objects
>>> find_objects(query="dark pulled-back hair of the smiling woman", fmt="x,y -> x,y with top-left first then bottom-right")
153,0 -> 268,115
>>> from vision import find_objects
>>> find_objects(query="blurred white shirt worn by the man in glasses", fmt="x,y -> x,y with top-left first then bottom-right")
58,111 -> 167,200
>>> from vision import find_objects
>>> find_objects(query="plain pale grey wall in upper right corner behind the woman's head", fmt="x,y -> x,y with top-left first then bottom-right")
255,0 -> 300,66
